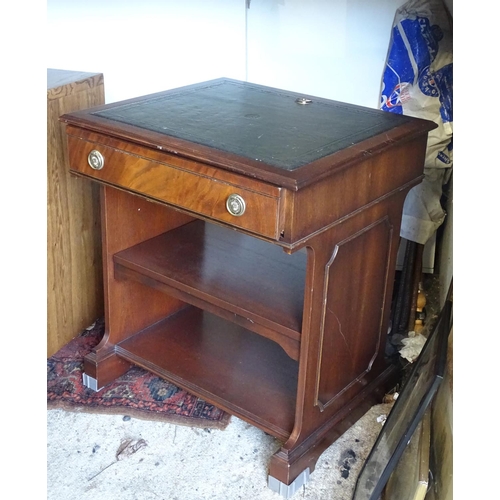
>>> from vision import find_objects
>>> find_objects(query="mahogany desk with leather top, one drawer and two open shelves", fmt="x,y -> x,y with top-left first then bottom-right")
61,79 -> 435,497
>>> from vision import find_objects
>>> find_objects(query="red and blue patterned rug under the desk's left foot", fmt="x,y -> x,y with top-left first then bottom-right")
47,319 -> 230,429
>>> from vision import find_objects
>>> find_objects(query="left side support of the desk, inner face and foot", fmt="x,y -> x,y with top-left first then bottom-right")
84,186 -> 193,390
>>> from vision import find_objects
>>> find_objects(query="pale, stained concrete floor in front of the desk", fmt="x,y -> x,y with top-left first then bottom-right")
47,404 -> 392,500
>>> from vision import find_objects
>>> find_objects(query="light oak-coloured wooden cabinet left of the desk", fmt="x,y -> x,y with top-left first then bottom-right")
47,70 -> 104,357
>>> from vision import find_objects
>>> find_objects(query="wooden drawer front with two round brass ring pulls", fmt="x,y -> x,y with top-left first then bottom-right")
68,136 -> 280,240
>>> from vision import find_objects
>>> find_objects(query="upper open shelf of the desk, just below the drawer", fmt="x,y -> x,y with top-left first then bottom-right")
114,220 -> 306,359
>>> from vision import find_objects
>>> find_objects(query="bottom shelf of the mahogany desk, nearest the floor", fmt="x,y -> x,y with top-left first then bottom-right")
116,306 -> 298,439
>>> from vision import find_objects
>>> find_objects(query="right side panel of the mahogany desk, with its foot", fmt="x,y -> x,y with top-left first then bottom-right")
269,195 -> 404,496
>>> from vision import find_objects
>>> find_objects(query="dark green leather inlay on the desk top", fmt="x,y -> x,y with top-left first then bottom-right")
93,79 -> 407,170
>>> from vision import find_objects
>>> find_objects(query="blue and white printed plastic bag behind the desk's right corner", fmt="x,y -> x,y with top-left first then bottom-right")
381,0 -> 453,244
